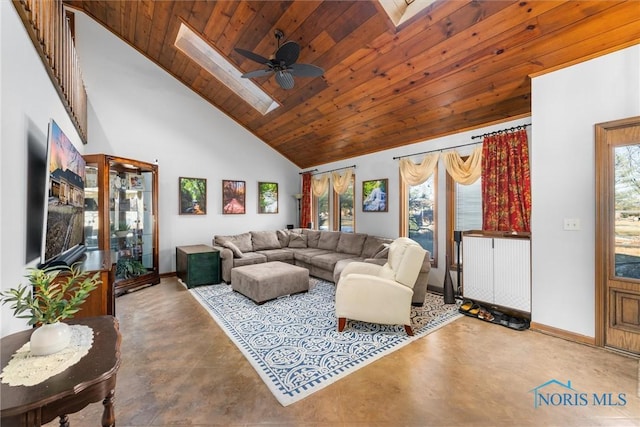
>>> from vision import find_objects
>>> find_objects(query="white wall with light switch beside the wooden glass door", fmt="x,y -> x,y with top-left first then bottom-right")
531,45 -> 640,337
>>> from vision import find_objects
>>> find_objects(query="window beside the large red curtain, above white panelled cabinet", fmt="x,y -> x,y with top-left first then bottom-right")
447,169 -> 482,268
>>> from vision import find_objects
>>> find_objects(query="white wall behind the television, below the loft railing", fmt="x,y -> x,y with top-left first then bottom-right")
0,1 -> 83,336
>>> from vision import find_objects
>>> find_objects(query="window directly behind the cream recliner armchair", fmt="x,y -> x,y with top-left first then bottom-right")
400,172 -> 437,265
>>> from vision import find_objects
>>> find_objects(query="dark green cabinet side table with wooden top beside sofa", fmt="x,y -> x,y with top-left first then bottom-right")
176,245 -> 221,288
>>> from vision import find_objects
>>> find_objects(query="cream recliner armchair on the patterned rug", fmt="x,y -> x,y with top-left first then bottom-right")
336,237 -> 427,335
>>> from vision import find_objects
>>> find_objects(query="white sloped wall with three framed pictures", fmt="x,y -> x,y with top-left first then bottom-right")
71,13 -> 300,273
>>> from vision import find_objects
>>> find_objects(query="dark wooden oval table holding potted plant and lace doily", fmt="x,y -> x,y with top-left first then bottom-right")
0,316 -> 121,427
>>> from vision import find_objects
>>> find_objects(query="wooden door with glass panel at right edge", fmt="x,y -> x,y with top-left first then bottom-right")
596,117 -> 640,354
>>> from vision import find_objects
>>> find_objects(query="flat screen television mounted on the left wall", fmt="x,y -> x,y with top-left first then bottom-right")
41,119 -> 86,267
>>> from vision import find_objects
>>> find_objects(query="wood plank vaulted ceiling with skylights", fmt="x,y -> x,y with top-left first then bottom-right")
65,0 -> 640,169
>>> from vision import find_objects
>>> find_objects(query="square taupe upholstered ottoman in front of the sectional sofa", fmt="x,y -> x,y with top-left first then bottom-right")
231,261 -> 309,304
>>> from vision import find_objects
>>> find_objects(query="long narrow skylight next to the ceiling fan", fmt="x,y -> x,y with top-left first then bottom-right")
174,22 -> 280,115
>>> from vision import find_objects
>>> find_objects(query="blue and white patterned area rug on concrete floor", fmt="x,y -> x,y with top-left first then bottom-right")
190,278 -> 462,406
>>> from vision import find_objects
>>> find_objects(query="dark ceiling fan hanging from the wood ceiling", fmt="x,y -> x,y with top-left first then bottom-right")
235,30 -> 324,89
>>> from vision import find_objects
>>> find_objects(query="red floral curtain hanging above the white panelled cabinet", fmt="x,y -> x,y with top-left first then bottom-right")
482,129 -> 531,232
